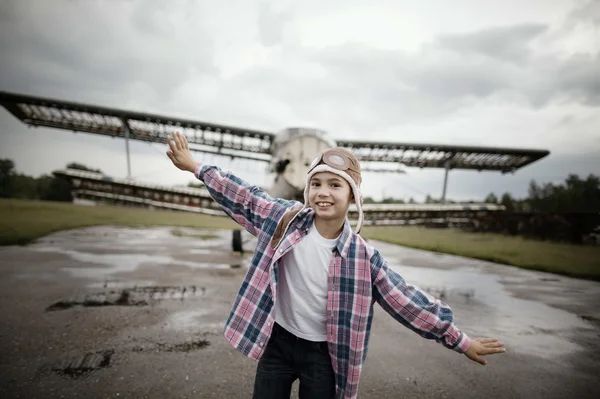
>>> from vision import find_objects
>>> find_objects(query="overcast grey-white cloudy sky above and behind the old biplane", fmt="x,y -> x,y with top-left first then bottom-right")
0,0 -> 600,200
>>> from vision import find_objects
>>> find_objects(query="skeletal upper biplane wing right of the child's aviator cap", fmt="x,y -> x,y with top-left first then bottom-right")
337,140 -> 550,173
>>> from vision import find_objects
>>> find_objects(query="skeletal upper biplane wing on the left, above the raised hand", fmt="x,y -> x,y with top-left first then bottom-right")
0,91 -> 275,162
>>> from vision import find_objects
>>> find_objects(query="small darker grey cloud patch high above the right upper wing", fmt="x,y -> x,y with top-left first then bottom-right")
435,24 -> 548,62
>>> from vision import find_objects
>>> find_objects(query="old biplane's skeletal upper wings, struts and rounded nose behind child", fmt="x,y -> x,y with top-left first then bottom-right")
0,91 -> 550,204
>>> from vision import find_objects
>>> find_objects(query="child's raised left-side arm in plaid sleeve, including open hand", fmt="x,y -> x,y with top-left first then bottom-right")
167,133 -> 287,236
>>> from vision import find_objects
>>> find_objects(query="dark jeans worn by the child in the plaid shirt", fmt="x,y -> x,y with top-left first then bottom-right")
253,324 -> 335,399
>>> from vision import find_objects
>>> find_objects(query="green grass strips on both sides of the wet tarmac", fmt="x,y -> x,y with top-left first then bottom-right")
0,199 -> 600,281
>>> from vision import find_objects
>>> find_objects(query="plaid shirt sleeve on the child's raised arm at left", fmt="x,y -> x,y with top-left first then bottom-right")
194,165 -> 284,236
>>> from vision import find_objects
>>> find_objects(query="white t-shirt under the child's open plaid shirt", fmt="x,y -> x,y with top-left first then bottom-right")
275,223 -> 337,341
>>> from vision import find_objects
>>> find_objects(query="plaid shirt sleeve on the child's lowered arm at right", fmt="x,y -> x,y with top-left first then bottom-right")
371,250 -> 471,353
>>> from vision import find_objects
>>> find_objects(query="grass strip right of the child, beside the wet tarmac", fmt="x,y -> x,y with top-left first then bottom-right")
362,226 -> 600,281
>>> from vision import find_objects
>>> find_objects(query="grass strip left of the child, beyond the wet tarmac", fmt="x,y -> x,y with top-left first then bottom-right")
0,199 -> 237,245
